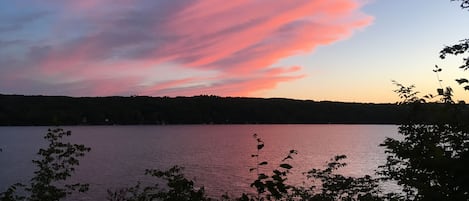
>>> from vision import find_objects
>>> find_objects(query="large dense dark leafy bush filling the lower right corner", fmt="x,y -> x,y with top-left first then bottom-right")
379,81 -> 469,200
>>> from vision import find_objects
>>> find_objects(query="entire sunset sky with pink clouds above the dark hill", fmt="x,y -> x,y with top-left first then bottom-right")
0,0 -> 469,103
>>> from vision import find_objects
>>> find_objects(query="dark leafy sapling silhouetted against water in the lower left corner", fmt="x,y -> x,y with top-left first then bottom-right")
0,128 -> 91,201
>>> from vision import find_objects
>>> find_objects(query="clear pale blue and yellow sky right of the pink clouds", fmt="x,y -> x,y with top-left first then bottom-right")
271,0 -> 469,102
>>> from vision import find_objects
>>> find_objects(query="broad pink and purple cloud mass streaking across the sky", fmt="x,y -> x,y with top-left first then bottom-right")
0,0 -> 372,96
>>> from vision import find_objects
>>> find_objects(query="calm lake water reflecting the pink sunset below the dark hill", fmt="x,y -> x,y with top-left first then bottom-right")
0,125 -> 398,200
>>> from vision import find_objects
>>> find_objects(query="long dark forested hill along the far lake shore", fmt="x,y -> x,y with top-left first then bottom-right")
0,95 -> 406,126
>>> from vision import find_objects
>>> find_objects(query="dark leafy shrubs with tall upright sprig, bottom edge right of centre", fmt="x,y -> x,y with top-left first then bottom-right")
237,134 -> 385,201
